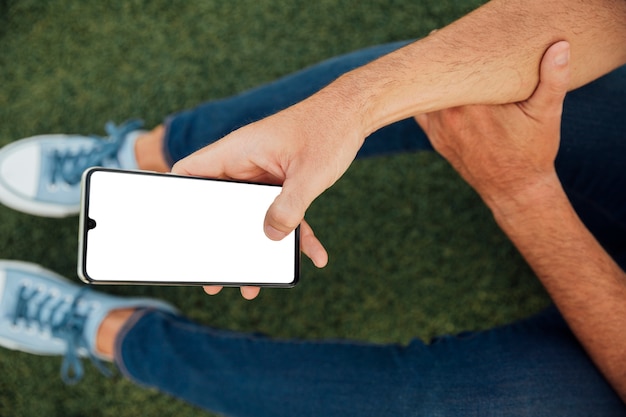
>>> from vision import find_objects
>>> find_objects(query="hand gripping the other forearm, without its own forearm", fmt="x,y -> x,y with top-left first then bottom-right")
416,42 -> 570,206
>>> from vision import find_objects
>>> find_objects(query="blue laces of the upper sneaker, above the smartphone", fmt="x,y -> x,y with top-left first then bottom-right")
50,120 -> 143,185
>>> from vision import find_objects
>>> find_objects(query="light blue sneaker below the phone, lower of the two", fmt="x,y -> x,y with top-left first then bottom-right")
0,260 -> 174,383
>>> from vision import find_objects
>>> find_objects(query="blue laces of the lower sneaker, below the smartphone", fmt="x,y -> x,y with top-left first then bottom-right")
13,284 -> 112,385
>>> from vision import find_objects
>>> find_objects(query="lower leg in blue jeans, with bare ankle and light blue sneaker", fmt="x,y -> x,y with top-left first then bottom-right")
0,261 -> 626,417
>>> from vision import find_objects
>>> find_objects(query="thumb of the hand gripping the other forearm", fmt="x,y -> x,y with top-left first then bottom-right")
526,41 -> 570,117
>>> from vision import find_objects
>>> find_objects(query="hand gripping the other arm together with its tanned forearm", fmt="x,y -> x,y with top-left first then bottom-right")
418,42 -> 626,401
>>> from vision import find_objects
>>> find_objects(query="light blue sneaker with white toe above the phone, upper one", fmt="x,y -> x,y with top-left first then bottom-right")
0,121 -> 144,217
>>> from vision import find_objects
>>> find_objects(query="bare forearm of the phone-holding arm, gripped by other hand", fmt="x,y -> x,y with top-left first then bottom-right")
322,0 -> 626,134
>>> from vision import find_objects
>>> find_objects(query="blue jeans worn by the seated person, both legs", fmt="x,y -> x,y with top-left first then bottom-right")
116,43 -> 626,417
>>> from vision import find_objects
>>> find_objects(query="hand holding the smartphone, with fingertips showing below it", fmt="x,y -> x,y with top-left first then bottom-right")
172,83 -> 365,299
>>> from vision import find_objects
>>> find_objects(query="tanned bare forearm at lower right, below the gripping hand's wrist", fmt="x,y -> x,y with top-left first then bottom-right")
486,175 -> 626,401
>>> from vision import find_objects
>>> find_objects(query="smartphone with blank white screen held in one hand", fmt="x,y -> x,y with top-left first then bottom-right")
78,168 -> 300,287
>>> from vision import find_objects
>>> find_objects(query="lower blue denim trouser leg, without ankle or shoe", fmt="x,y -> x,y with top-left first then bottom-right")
109,308 -> 626,417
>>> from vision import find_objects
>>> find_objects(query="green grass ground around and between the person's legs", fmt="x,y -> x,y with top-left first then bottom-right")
0,0 -> 548,417
